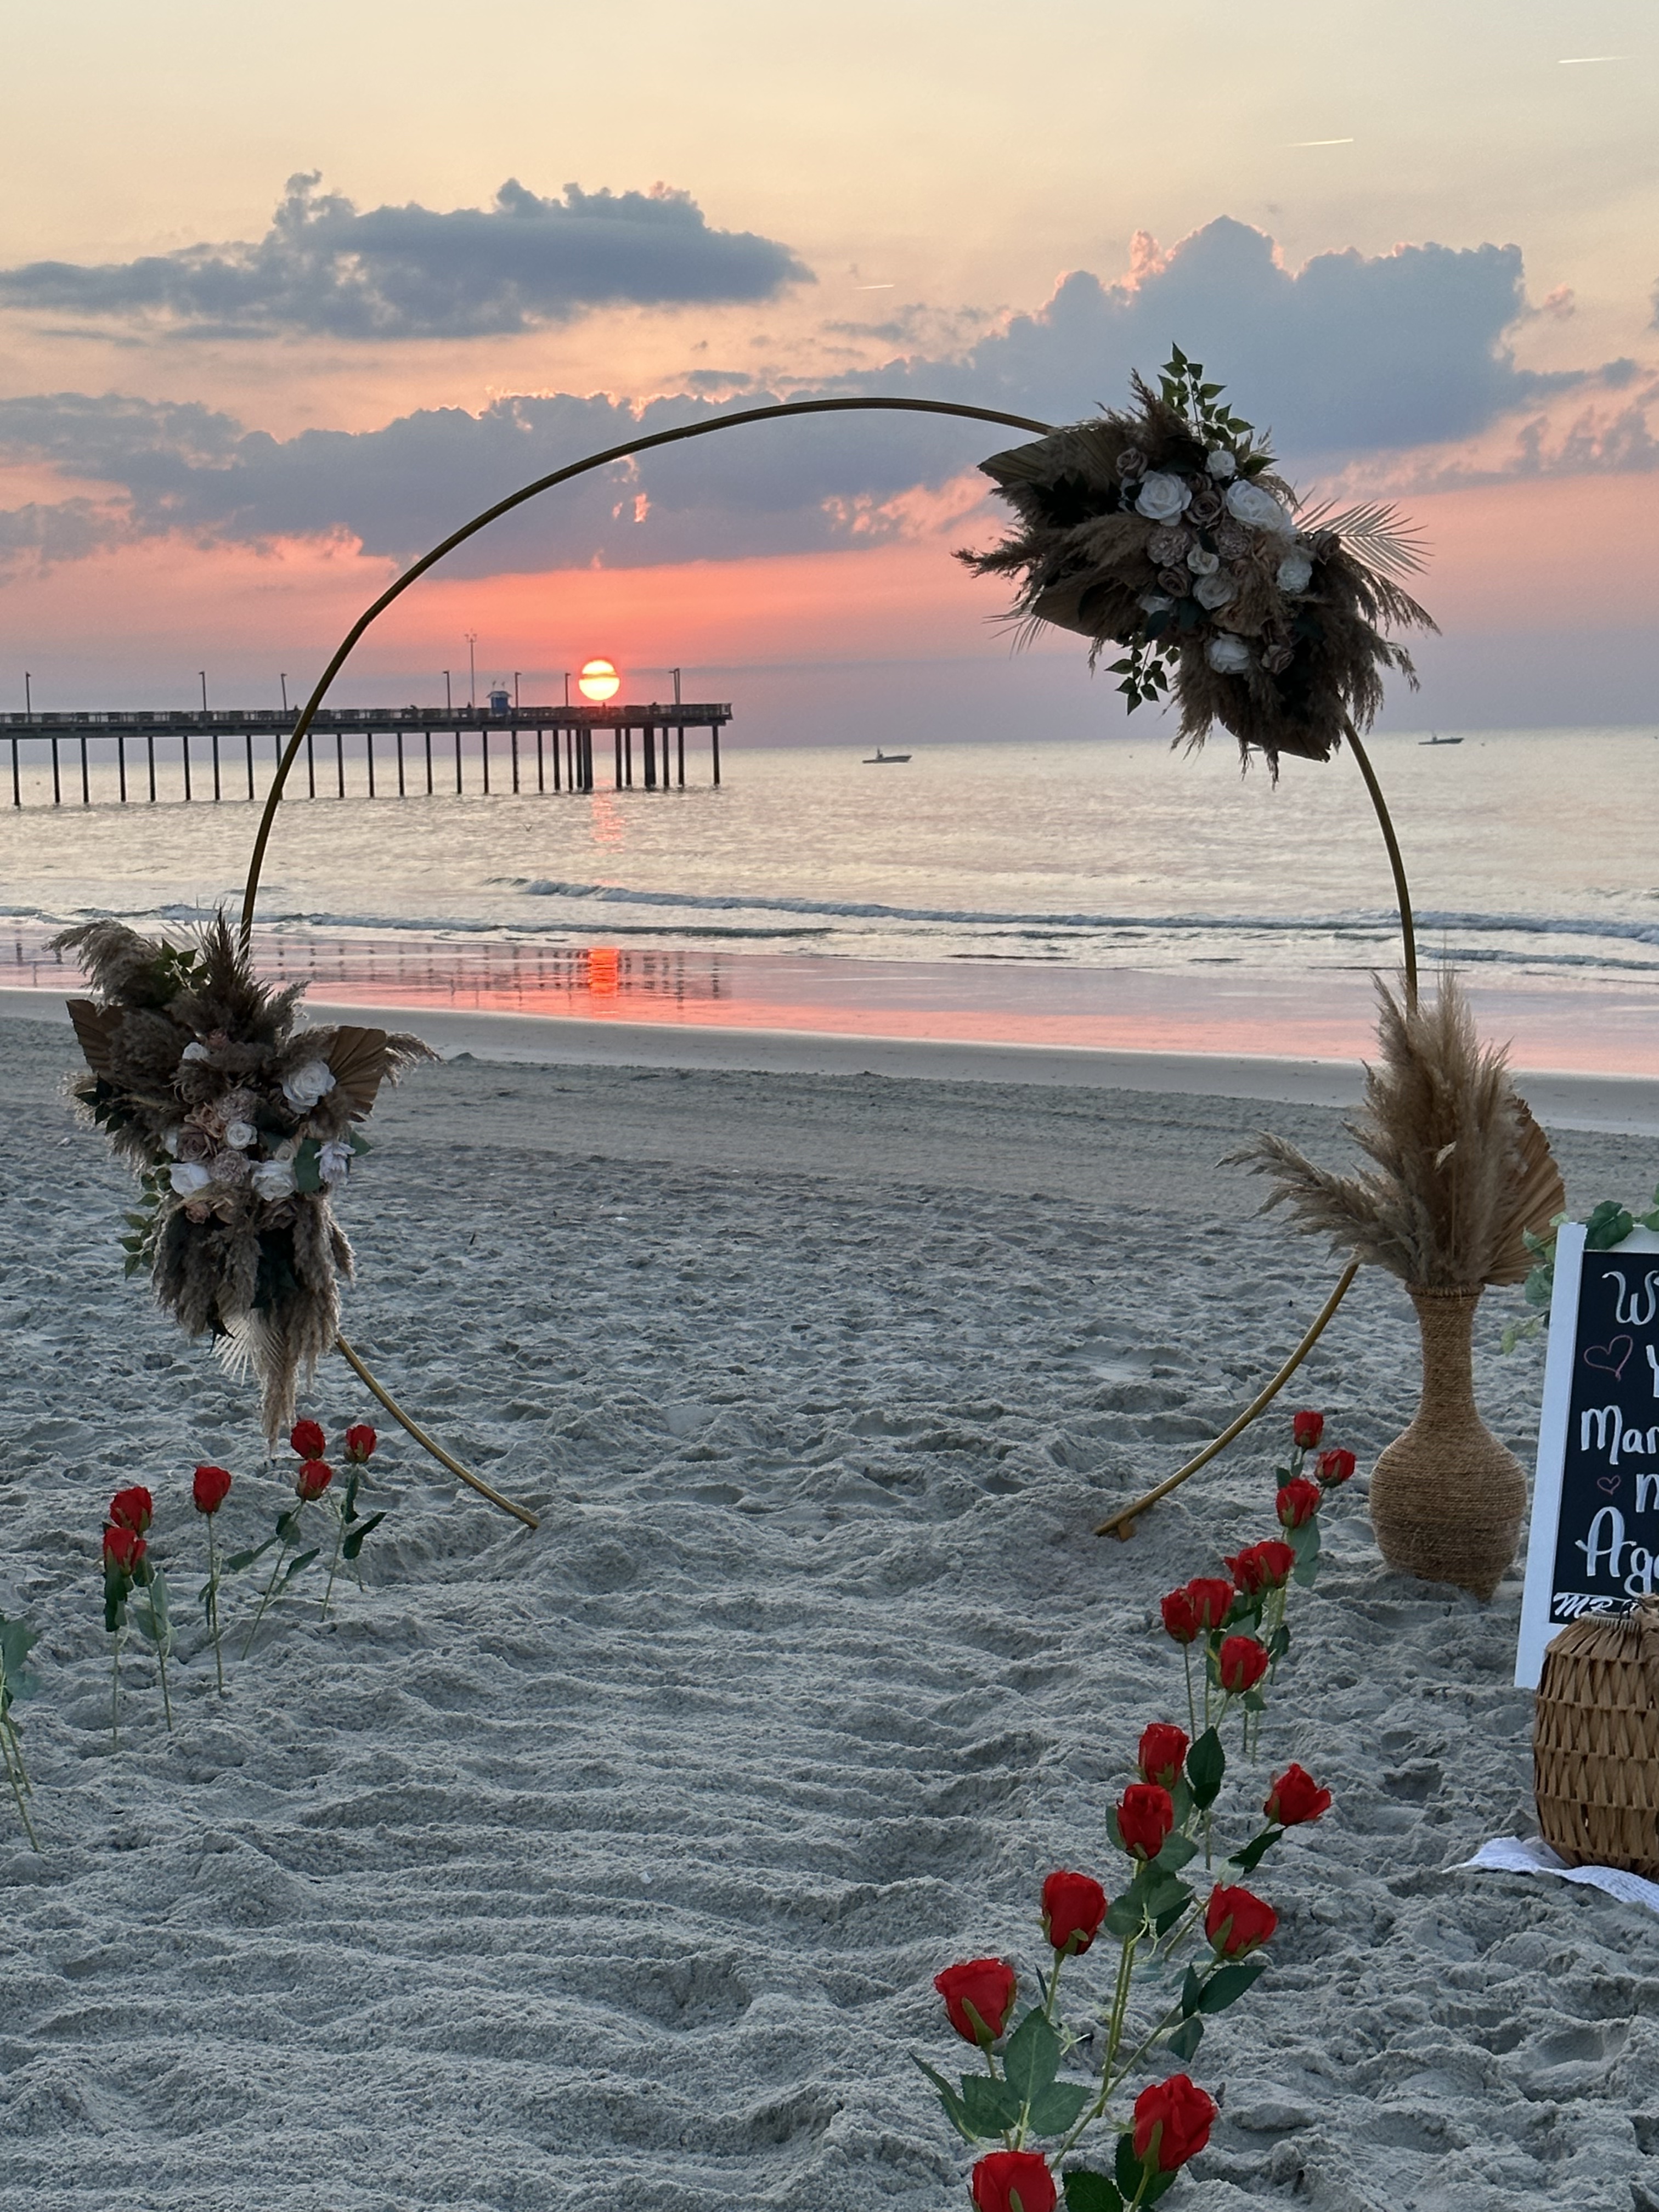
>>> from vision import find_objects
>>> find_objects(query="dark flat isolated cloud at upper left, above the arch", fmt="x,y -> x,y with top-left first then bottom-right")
0,175 -> 812,341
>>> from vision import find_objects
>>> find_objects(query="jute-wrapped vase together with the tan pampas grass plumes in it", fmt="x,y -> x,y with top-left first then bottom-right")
1234,971 -> 1566,1599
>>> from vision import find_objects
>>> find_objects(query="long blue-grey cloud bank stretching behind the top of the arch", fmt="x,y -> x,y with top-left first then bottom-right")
0,221 -> 1652,573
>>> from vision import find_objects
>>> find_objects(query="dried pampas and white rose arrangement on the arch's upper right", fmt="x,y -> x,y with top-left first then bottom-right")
958,347 -> 1436,774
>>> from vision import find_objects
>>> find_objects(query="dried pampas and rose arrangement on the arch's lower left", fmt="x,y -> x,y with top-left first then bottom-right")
53,913 -> 433,1442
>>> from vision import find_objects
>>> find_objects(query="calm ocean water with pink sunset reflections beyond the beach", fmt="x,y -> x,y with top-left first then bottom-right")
0,728 -> 1659,1073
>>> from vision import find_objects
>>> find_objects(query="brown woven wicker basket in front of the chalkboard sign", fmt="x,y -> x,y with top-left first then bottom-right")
1533,1597 -> 1659,1880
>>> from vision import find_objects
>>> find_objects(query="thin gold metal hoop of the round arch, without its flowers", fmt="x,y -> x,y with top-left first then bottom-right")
241,396 -> 1418,1539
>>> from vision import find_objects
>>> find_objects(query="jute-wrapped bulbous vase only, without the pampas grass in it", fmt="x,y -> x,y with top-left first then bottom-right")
1372,1285 -> 1526,1599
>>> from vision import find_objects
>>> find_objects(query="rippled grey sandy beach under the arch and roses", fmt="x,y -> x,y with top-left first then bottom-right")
0,993 -> 1659,2212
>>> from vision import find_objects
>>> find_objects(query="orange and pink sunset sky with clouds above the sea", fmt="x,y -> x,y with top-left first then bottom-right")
0,0 -> 1659,739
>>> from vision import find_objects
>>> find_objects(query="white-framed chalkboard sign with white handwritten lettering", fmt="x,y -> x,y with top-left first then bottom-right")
1515,1221 -> 1659,1690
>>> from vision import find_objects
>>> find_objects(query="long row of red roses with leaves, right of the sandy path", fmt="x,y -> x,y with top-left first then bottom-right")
918,1411 -> 1354,2212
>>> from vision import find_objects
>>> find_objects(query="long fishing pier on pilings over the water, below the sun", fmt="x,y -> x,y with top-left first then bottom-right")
0,699 -> 732,808
